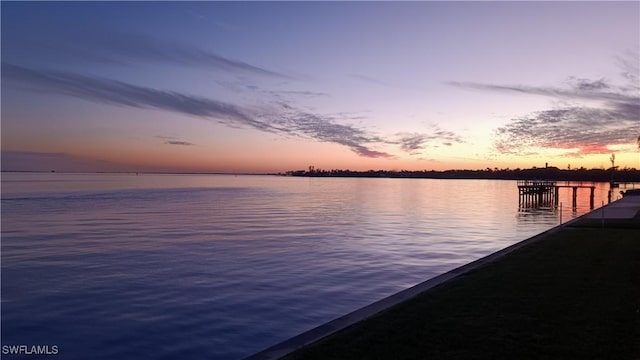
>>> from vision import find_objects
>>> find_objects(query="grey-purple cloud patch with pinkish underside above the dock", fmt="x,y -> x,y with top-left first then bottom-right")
449,56 -> 640,157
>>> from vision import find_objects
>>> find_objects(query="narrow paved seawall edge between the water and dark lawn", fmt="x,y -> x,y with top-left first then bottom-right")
244,201 -> 615,360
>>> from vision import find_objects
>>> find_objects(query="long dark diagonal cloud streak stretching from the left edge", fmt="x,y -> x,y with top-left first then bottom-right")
2,63 -> 392,157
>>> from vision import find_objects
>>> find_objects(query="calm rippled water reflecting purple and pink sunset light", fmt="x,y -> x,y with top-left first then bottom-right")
1,173 -> 620,359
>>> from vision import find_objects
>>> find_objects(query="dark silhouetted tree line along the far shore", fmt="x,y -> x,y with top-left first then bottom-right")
285,166 -> 640,182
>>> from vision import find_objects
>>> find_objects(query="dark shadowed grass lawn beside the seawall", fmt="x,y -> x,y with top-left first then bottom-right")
286,219 -> 640,360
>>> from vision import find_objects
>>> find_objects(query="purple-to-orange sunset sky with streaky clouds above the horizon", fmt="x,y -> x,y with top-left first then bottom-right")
0,1 -> 640,173
